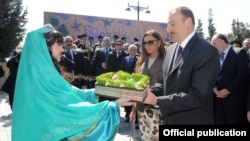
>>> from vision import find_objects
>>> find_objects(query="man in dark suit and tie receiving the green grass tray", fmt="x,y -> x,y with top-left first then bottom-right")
144,7 -> 219,125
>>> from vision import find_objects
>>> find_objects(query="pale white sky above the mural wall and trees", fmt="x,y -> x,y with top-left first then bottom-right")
23,0 -> 250,36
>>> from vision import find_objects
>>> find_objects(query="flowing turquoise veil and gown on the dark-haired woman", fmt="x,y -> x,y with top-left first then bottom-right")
12,25 -> 120,141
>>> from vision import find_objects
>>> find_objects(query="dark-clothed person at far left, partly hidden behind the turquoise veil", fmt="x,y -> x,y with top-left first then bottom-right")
1,45 -> 23,109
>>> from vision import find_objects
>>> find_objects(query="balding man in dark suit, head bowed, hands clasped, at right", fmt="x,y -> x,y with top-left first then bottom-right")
211,34 -> 248,125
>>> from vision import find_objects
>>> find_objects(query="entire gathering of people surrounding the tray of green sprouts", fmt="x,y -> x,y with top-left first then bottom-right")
2,4 -> 250,141
